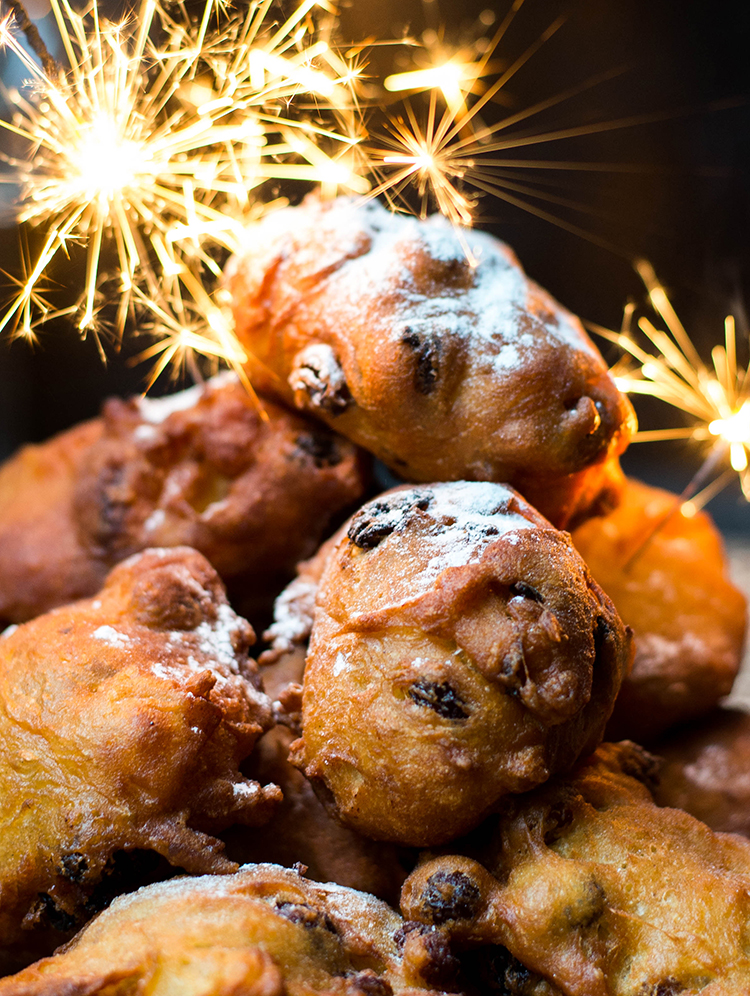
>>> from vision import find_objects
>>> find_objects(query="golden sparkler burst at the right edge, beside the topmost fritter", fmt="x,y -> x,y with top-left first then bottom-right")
589,260 -> 750,514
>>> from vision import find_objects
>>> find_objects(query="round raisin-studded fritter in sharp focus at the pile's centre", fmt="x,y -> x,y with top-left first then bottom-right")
290,481 -> 630,846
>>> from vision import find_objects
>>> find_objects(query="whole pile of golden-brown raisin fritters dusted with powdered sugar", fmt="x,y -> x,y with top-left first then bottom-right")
0,197 -> 750,996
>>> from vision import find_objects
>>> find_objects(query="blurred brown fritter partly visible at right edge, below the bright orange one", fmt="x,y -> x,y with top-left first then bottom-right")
654,708 -> 750,837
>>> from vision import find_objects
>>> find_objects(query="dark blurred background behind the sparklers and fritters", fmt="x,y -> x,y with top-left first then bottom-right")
0,0 -> 750,533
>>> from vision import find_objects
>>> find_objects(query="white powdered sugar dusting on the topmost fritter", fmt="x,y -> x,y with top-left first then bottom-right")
245,197 -> 600,368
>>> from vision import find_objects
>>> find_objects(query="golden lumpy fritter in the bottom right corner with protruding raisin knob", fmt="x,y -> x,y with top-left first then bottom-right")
402,743 -> 750,996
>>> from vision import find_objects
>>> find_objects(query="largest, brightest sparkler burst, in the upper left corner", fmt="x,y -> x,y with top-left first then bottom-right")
0,0 -> 368,346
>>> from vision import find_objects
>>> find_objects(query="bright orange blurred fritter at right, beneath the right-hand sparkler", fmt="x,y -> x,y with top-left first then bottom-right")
573,480 -> 747,743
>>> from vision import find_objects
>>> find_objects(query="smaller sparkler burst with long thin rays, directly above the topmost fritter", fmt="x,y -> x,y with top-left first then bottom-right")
368,0 -> 645,252
